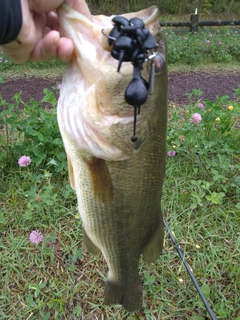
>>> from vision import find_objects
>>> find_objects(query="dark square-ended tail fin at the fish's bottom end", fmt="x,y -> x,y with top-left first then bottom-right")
104,278 -> 142,312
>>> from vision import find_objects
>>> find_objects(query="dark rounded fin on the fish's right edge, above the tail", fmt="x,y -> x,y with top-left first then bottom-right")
143,218 -> 164,263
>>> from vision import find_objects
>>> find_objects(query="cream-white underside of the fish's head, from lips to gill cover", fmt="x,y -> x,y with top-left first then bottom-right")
58,3 -> 159,161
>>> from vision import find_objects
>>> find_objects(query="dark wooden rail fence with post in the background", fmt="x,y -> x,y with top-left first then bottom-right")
160,9 -> 240,33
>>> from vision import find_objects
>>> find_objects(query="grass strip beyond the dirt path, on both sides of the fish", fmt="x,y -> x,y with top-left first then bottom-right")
0,20 -> 240,82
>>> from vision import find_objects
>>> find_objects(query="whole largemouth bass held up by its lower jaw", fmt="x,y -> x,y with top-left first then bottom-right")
57,1 -> 168,312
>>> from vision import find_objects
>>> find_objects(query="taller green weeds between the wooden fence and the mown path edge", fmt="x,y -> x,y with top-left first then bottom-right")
164,27 -> 240,65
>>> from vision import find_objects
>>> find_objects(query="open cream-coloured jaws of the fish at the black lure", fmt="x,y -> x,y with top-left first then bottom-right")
58,2 -> 160,65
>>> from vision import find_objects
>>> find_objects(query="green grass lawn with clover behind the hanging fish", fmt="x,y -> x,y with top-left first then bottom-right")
0,20 -> 240,320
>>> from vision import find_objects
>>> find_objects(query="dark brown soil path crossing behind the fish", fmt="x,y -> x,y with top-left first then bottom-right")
0,72 -> 240,106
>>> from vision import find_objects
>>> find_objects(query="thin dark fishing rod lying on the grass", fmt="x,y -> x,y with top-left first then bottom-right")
163,219 -> 217,320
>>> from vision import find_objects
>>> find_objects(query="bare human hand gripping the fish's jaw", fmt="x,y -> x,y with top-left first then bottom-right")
0,0 -> 74,63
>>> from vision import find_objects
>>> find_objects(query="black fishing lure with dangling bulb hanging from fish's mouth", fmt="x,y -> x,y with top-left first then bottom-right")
102,16 -> 158,142
